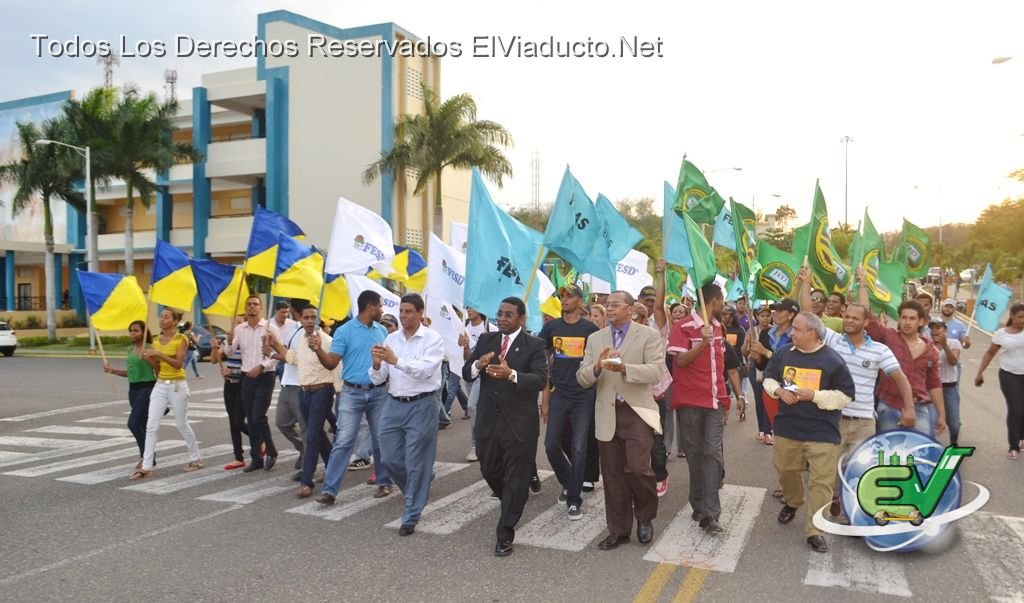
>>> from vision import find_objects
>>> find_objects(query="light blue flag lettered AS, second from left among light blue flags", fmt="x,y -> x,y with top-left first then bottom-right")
544,166 -> 598,281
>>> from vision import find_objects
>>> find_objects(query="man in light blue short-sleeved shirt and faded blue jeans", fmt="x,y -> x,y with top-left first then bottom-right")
310,291 -> 392,506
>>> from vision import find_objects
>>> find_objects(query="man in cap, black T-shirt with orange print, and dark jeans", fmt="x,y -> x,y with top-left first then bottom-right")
540,286 -> 598,520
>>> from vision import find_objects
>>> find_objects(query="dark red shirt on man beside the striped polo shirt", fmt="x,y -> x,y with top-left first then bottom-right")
865,314 -> 942,410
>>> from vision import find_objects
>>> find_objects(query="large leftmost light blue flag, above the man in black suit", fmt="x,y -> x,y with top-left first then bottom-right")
464,168 -> 544,331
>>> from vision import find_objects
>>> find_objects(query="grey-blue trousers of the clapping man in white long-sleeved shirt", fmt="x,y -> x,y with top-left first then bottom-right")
377,391 -> 440,525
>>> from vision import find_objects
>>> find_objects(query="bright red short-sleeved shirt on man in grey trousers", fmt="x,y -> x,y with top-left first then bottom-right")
666,311 -> 729,408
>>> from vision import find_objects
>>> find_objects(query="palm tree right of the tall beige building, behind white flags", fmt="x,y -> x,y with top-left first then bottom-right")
362,84 -> 512,238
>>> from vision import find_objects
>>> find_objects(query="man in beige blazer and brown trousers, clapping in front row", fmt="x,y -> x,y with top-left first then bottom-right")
577,291 -> 665,551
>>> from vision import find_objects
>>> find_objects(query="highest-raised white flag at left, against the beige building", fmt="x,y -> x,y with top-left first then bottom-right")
324,197 -> 394,274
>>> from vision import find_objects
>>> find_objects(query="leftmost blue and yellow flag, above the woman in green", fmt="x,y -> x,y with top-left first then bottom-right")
78,270 -> 148,331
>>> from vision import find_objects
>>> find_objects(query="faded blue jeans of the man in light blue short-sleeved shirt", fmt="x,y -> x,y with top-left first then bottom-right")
324,387 -> 391,497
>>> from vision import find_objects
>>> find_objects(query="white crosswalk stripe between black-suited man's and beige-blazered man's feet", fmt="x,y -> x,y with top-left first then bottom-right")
515,483 -> 608,552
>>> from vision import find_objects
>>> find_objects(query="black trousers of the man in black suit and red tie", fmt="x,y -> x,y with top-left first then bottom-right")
476,413 -> 537,541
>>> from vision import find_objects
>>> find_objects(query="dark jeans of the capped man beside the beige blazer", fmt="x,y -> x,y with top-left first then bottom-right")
544,390 -> 594,506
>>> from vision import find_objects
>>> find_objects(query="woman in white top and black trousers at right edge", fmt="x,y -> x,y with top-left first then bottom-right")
974,303 -> 1024,461
